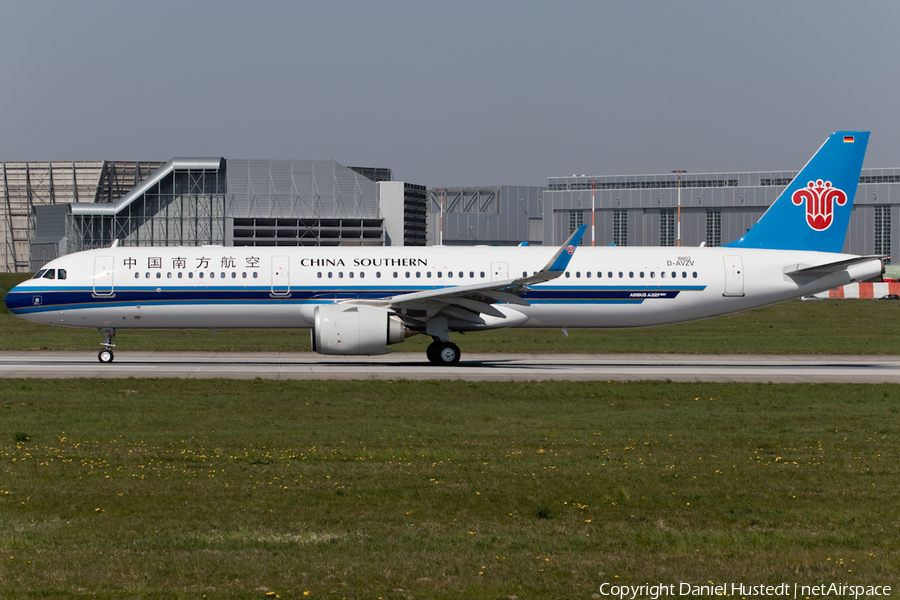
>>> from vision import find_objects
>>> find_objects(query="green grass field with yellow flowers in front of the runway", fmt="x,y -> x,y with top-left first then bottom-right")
0,380 -> 900,599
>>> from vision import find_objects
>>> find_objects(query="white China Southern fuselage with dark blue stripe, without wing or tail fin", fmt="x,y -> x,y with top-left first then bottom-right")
7,246 -> 881,329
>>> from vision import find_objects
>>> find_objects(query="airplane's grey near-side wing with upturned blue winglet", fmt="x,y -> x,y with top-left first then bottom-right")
356,225 -> 587,323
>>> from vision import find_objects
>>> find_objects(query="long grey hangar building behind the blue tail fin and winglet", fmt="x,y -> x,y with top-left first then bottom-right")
428,169 -> 900,255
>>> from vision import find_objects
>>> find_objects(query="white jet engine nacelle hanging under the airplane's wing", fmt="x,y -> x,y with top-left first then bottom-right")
311,304 -> 407,354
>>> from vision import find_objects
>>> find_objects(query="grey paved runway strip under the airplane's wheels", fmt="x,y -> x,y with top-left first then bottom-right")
0,351 -> 900,383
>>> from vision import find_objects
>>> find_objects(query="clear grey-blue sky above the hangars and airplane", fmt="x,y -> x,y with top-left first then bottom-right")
0,0 -> 900,187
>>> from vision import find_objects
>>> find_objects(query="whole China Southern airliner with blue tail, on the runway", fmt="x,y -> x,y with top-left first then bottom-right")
6,131 -> 883,366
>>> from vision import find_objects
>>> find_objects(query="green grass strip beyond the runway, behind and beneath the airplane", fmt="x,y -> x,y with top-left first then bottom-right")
0,275 -> 900,354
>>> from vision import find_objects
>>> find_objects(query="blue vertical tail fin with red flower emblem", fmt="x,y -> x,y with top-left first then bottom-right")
724,131 -> 869,252
